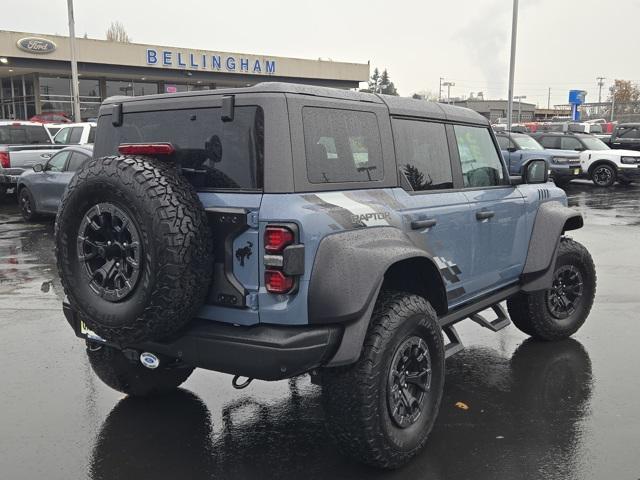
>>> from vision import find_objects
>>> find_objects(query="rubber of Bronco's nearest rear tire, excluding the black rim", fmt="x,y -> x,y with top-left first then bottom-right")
321,291 -> 444,468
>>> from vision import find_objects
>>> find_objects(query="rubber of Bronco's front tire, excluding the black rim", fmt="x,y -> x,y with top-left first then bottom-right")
507,237 -> 596,341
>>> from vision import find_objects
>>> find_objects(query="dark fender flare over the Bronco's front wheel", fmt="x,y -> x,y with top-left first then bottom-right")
522,201 -> 584,292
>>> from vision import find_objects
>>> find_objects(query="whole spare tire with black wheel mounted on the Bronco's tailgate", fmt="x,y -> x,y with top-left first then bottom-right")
55,156 -> 213,345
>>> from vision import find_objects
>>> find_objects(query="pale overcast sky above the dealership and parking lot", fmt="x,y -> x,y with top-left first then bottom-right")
5,0 -> 640,106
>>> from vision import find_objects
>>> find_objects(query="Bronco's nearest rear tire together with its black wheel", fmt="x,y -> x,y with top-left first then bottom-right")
322,292 -> 444,468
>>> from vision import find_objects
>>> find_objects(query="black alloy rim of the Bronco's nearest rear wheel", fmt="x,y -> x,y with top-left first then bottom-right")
387,336 -> 432,428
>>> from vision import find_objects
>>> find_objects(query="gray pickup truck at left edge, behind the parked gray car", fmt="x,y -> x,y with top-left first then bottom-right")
0,120 -> 65,197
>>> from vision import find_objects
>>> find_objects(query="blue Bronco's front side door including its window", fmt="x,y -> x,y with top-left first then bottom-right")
453,125 -> 528,294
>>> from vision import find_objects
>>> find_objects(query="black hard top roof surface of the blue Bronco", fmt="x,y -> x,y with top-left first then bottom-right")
103,82 -> 489,126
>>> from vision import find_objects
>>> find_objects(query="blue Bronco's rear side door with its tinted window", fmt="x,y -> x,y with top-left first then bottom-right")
392,118 -> 473,306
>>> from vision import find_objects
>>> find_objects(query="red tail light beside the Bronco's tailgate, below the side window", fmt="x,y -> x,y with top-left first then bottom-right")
264,225 -> 304,295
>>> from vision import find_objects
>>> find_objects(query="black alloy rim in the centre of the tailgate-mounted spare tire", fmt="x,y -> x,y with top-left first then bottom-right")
77,202 -> 142,302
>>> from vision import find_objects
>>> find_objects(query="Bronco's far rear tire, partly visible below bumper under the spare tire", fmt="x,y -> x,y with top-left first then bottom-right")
87,343 -> 193,397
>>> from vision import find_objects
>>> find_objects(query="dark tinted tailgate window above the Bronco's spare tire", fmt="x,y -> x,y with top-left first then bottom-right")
94,107 -> 264,190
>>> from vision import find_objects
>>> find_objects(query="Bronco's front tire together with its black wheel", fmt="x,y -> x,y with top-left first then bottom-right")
507,238 -> 596,340
